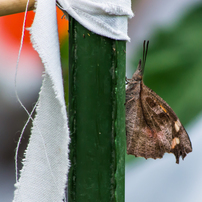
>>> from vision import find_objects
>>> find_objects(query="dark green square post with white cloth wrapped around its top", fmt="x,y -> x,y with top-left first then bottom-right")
68,17 -> 126,202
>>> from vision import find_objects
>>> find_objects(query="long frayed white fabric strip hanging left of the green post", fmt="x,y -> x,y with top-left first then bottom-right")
13,0 -> 69,202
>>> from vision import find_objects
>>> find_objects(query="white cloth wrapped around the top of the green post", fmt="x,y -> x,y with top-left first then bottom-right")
58,0 -> 133,41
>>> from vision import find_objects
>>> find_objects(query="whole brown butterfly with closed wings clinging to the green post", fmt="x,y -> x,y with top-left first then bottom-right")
126,41 -> 192,163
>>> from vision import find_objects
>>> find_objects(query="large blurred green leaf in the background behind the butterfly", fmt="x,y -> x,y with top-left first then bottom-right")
126,6 -> 202,162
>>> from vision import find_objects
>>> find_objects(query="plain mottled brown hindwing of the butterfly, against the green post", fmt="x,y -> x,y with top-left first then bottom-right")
126,80 -> 171,159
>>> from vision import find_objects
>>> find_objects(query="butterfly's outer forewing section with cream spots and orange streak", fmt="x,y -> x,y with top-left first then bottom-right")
141,84 -> 192,163
